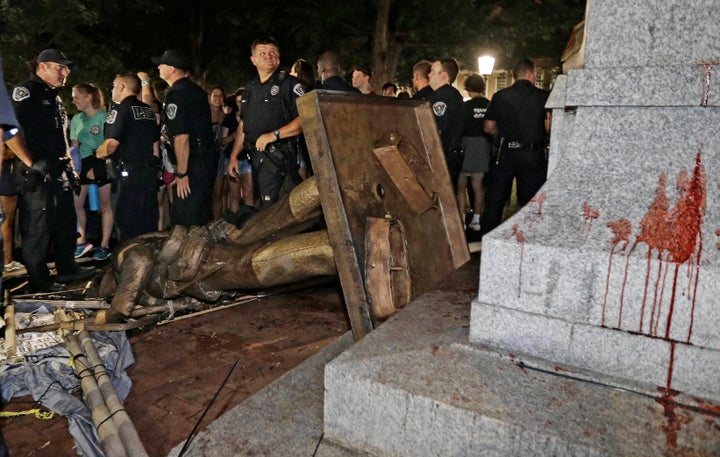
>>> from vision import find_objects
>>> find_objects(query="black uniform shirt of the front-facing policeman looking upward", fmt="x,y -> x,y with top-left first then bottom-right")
240,70 -> 305,144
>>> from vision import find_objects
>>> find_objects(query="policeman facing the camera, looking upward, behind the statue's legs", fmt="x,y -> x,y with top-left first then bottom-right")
228,37 -> 304,209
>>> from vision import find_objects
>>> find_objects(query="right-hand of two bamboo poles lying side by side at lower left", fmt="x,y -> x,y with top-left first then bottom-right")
78,331 -> 148,457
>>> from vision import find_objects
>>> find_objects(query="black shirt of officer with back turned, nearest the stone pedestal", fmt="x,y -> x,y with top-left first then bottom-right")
485,79 -> 550,144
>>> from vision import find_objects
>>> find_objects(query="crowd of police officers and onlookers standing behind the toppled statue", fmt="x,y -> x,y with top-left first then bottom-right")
0,36 -> 549,292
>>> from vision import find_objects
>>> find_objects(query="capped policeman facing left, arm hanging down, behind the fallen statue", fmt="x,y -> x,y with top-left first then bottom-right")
152,49 -> 218,226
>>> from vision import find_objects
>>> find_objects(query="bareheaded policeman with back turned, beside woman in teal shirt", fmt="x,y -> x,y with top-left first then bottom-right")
97,73 -> 160,241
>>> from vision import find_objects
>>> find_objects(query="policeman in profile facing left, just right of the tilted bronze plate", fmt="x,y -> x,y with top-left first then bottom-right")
428,58 -> 464,188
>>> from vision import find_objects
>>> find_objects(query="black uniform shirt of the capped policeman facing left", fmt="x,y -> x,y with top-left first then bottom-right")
162,78 -> 213,149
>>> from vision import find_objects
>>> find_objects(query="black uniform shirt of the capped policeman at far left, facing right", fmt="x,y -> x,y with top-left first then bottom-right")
12,75 -> 67,160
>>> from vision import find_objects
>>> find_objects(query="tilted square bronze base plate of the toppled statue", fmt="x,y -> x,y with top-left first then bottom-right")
298,91 -> 470,339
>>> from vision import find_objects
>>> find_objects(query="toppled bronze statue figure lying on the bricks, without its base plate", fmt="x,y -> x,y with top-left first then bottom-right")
95,178 -> 337,322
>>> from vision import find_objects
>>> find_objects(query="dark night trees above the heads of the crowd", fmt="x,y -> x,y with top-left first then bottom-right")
0,0 -> 585,99
